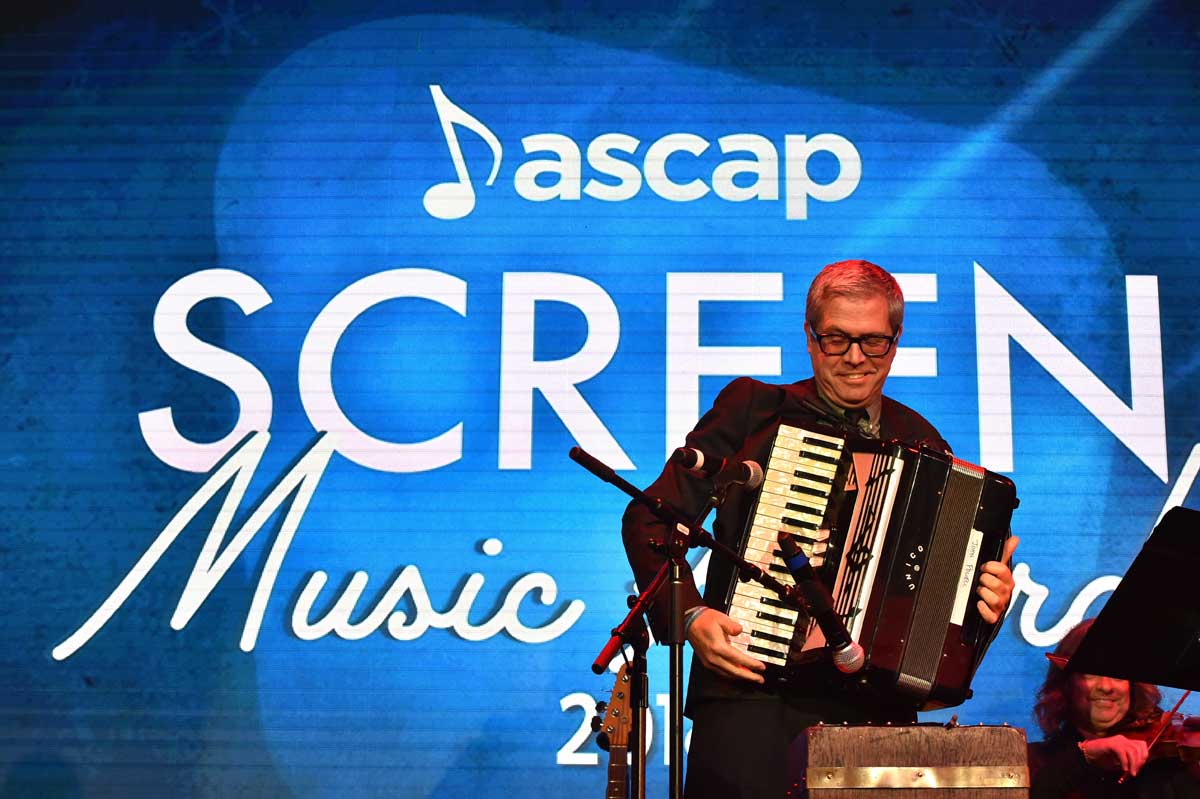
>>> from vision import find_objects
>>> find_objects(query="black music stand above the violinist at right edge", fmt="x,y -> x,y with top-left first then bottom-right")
1064,507 -> 1200,691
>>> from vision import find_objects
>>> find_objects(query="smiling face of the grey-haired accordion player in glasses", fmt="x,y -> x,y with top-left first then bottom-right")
804,295 -> 899,408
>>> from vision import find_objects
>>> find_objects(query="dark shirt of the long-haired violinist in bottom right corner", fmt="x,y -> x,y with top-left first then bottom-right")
1030,731 -> 1200,799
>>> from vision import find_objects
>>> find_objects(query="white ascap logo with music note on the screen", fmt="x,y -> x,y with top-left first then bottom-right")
425,85 -> 863,220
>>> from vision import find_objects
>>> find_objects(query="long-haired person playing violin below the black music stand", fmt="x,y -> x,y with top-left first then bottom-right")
1030,619 -> 1200,799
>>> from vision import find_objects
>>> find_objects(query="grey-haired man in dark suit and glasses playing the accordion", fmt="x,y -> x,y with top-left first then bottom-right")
623,260 -> 1016,799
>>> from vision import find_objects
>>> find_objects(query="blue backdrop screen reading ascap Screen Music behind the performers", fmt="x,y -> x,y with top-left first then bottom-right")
0,1 -> 1200,799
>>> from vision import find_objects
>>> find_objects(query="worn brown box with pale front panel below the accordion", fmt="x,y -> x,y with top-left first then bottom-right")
792,725 -> 1030,799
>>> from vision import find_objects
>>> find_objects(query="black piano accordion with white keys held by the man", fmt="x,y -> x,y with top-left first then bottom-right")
726,420 -> 1018,709
